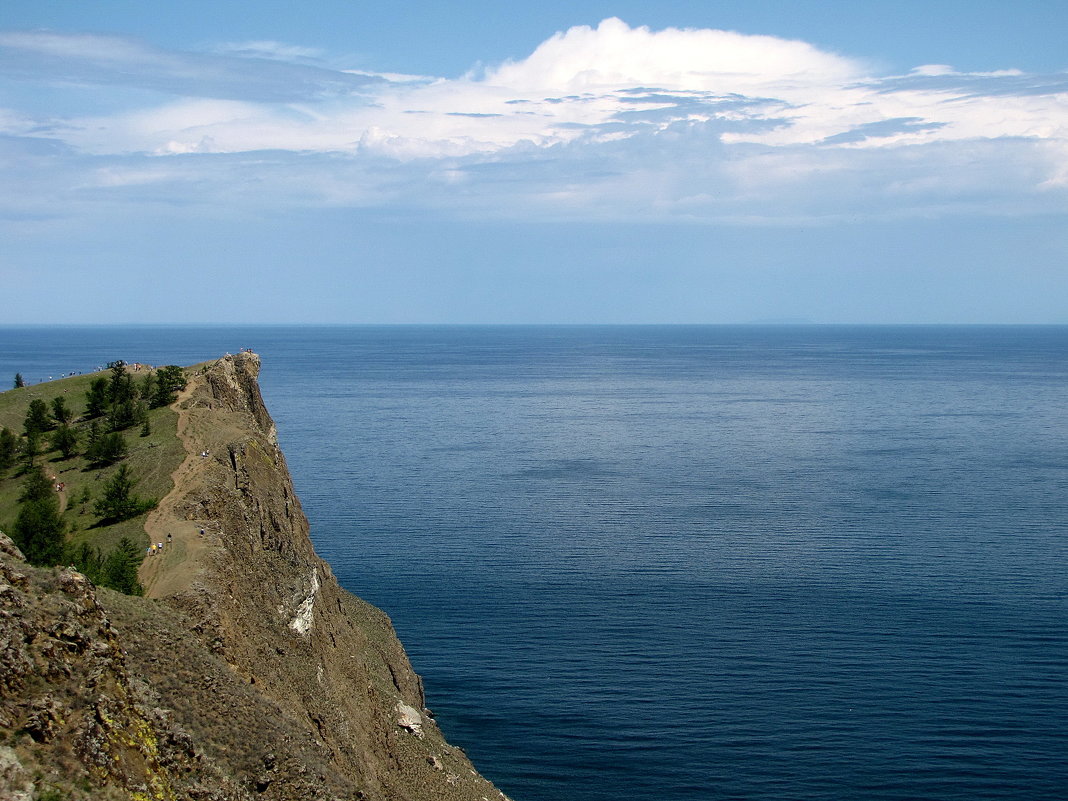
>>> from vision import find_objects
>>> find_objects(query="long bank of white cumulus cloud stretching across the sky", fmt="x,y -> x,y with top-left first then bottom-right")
0,19 -> 1068,220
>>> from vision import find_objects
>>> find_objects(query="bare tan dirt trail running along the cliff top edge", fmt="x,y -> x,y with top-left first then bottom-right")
138,375 -> 211,598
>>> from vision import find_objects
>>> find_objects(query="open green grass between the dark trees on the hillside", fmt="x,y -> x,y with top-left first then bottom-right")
0,371 -> 185,553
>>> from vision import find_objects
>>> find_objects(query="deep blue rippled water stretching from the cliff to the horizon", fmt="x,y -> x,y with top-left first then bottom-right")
0,327 -> 1068,801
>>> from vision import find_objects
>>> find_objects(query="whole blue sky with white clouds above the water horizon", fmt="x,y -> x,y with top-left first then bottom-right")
0,0 -> 1068,324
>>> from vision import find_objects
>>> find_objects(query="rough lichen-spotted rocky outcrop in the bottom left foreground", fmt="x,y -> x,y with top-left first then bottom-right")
0,534 -> 240,801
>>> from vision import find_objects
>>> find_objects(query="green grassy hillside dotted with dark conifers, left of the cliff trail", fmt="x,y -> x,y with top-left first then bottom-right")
0,361 -> 185,593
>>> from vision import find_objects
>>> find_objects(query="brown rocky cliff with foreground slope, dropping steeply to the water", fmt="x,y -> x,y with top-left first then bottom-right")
0,354 -> 503,801
